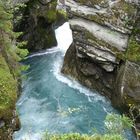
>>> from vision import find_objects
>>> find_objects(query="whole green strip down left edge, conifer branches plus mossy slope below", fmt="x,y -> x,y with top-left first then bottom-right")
0,0 -> 28,119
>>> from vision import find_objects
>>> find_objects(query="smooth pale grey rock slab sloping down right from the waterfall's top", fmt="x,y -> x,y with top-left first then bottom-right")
69,18 -> 128,51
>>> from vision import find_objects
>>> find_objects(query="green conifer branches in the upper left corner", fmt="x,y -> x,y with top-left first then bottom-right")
0,1 -> 28,61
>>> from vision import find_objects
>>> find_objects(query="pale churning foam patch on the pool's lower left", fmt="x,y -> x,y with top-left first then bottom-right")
14,97 -> 47,140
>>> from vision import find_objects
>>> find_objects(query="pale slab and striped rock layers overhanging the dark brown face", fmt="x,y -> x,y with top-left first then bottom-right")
69,18 -> 128,72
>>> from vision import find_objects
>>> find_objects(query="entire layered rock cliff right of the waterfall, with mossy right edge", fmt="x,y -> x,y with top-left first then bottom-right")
62,0 -> 140,135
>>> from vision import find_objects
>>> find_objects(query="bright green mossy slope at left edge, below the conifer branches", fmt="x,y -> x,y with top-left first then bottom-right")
0,54 -> 17,118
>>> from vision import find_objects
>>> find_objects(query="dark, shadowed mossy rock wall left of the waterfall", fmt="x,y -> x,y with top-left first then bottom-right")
15,0 -> 57,51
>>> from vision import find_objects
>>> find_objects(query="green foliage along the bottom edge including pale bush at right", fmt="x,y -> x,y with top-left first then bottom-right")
43,114 -> 133,140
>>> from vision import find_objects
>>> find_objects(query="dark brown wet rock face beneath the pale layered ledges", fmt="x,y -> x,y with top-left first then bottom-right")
62,44 -> 114,99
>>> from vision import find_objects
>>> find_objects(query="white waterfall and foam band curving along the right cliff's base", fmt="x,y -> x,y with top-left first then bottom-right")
53,22 -> 106,102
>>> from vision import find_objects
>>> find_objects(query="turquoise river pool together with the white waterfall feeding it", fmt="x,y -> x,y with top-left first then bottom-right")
13,23 -> 133,140
